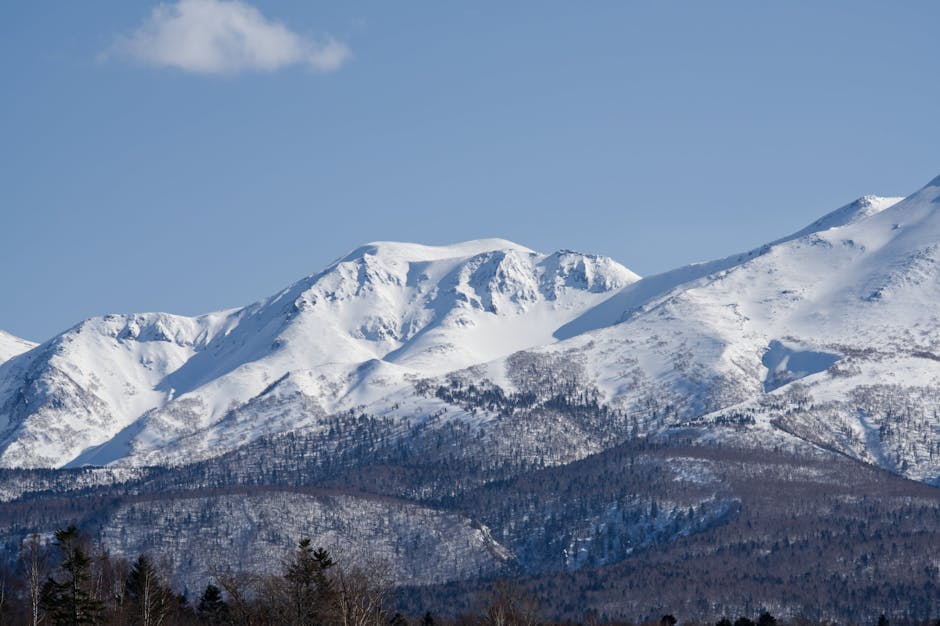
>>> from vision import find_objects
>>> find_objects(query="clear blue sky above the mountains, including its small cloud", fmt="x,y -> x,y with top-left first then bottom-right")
0,0 -> 940,340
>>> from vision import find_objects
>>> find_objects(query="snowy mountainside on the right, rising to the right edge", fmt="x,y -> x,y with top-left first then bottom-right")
490,178 -> 940,481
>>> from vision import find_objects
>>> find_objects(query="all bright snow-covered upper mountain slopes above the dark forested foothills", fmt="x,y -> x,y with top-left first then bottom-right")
9,178 -> 940,481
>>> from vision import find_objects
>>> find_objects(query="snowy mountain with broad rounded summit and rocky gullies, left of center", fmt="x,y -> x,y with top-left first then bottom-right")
0,240 -> 638,467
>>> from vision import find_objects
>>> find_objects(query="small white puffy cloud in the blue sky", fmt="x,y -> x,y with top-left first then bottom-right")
109,0 -> 350,74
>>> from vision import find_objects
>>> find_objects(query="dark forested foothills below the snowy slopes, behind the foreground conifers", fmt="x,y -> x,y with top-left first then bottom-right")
0,380 -> 940,626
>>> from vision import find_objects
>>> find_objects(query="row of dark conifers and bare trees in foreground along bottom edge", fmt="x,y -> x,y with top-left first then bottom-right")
0,526 -> 940,626
